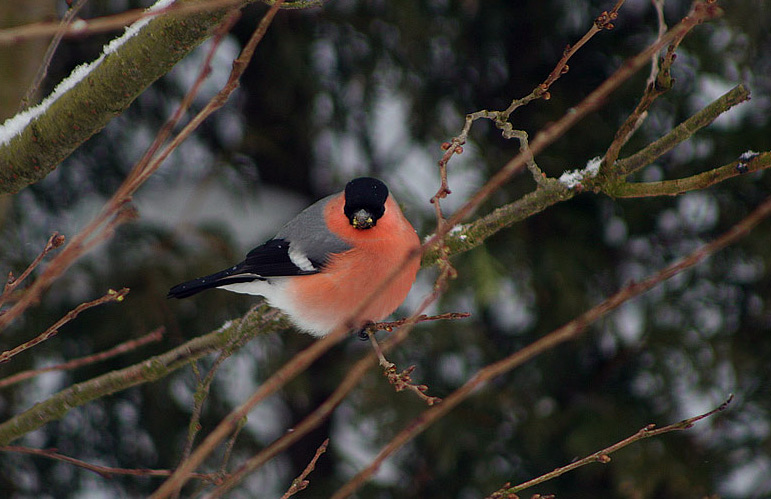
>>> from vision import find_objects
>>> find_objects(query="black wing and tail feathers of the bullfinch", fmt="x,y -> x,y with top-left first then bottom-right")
166,239 -> 323,298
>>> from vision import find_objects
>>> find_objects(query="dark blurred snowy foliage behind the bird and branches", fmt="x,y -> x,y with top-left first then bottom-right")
0,0 -> 771,498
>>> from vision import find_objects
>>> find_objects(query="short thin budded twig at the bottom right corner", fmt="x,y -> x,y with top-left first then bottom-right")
488,395 -> 733,499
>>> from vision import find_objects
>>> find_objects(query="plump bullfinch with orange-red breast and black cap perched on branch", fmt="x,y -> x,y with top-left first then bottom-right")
168,177 -> 420,336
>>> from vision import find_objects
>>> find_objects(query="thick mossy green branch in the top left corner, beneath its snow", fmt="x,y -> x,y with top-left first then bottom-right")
0,0 -> 244,194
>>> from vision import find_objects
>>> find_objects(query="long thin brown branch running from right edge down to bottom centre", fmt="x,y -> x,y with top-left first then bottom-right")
333,190 -> 771,499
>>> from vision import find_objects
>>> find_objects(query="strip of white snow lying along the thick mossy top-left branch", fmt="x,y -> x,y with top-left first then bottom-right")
0,0 -> 175,146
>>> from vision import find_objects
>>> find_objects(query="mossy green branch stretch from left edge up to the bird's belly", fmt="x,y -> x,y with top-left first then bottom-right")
0,305 -> 288,446
